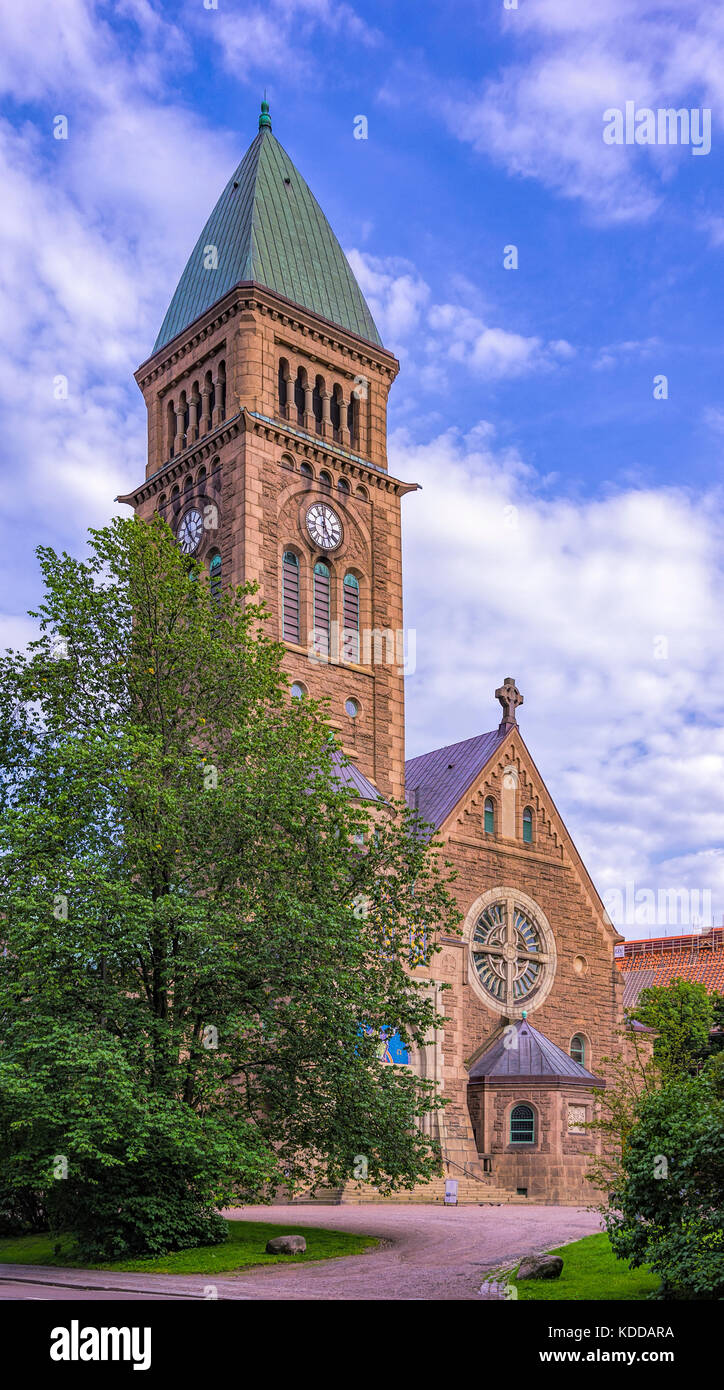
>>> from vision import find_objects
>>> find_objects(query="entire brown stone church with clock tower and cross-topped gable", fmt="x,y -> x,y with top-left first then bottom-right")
120,101 -> 623,1204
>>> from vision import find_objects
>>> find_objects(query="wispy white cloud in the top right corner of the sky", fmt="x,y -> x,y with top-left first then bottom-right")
436,0 -> 724,219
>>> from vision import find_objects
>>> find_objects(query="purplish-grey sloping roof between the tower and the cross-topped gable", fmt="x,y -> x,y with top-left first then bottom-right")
404,728 -> 509,828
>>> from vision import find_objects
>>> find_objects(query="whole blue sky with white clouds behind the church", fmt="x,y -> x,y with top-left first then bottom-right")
0,0 -> 724,935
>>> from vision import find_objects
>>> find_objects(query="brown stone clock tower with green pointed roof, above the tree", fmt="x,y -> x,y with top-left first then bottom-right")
121,103 -> 414,796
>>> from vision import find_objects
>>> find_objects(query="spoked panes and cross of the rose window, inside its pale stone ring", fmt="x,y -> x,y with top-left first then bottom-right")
471,899 -> 550,1011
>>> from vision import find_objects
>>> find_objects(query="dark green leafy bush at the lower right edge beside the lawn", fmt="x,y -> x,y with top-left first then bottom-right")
606,1054 -> 724,1298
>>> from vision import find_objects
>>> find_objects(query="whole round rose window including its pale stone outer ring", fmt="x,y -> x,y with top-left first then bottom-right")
467,888 -> 556,1017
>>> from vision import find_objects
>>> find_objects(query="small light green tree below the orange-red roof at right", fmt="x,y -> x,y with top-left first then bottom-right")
632,979 -> 714,1074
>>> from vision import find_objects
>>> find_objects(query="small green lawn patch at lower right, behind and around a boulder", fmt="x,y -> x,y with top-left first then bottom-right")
510,1233 -> 660,1302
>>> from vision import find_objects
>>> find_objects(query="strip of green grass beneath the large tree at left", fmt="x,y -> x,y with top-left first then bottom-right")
0,1220 -> 378,1275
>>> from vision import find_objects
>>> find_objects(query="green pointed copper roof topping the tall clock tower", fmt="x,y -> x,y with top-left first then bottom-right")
153,114 -> 382,353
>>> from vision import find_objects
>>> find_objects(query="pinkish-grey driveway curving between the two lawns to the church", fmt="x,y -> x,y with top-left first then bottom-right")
0,1205 -> 600,1301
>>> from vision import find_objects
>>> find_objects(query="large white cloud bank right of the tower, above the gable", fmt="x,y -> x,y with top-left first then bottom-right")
390,425 -> 724,934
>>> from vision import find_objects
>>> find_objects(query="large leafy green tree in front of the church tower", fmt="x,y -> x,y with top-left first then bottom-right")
0,520 -> 457,1257
